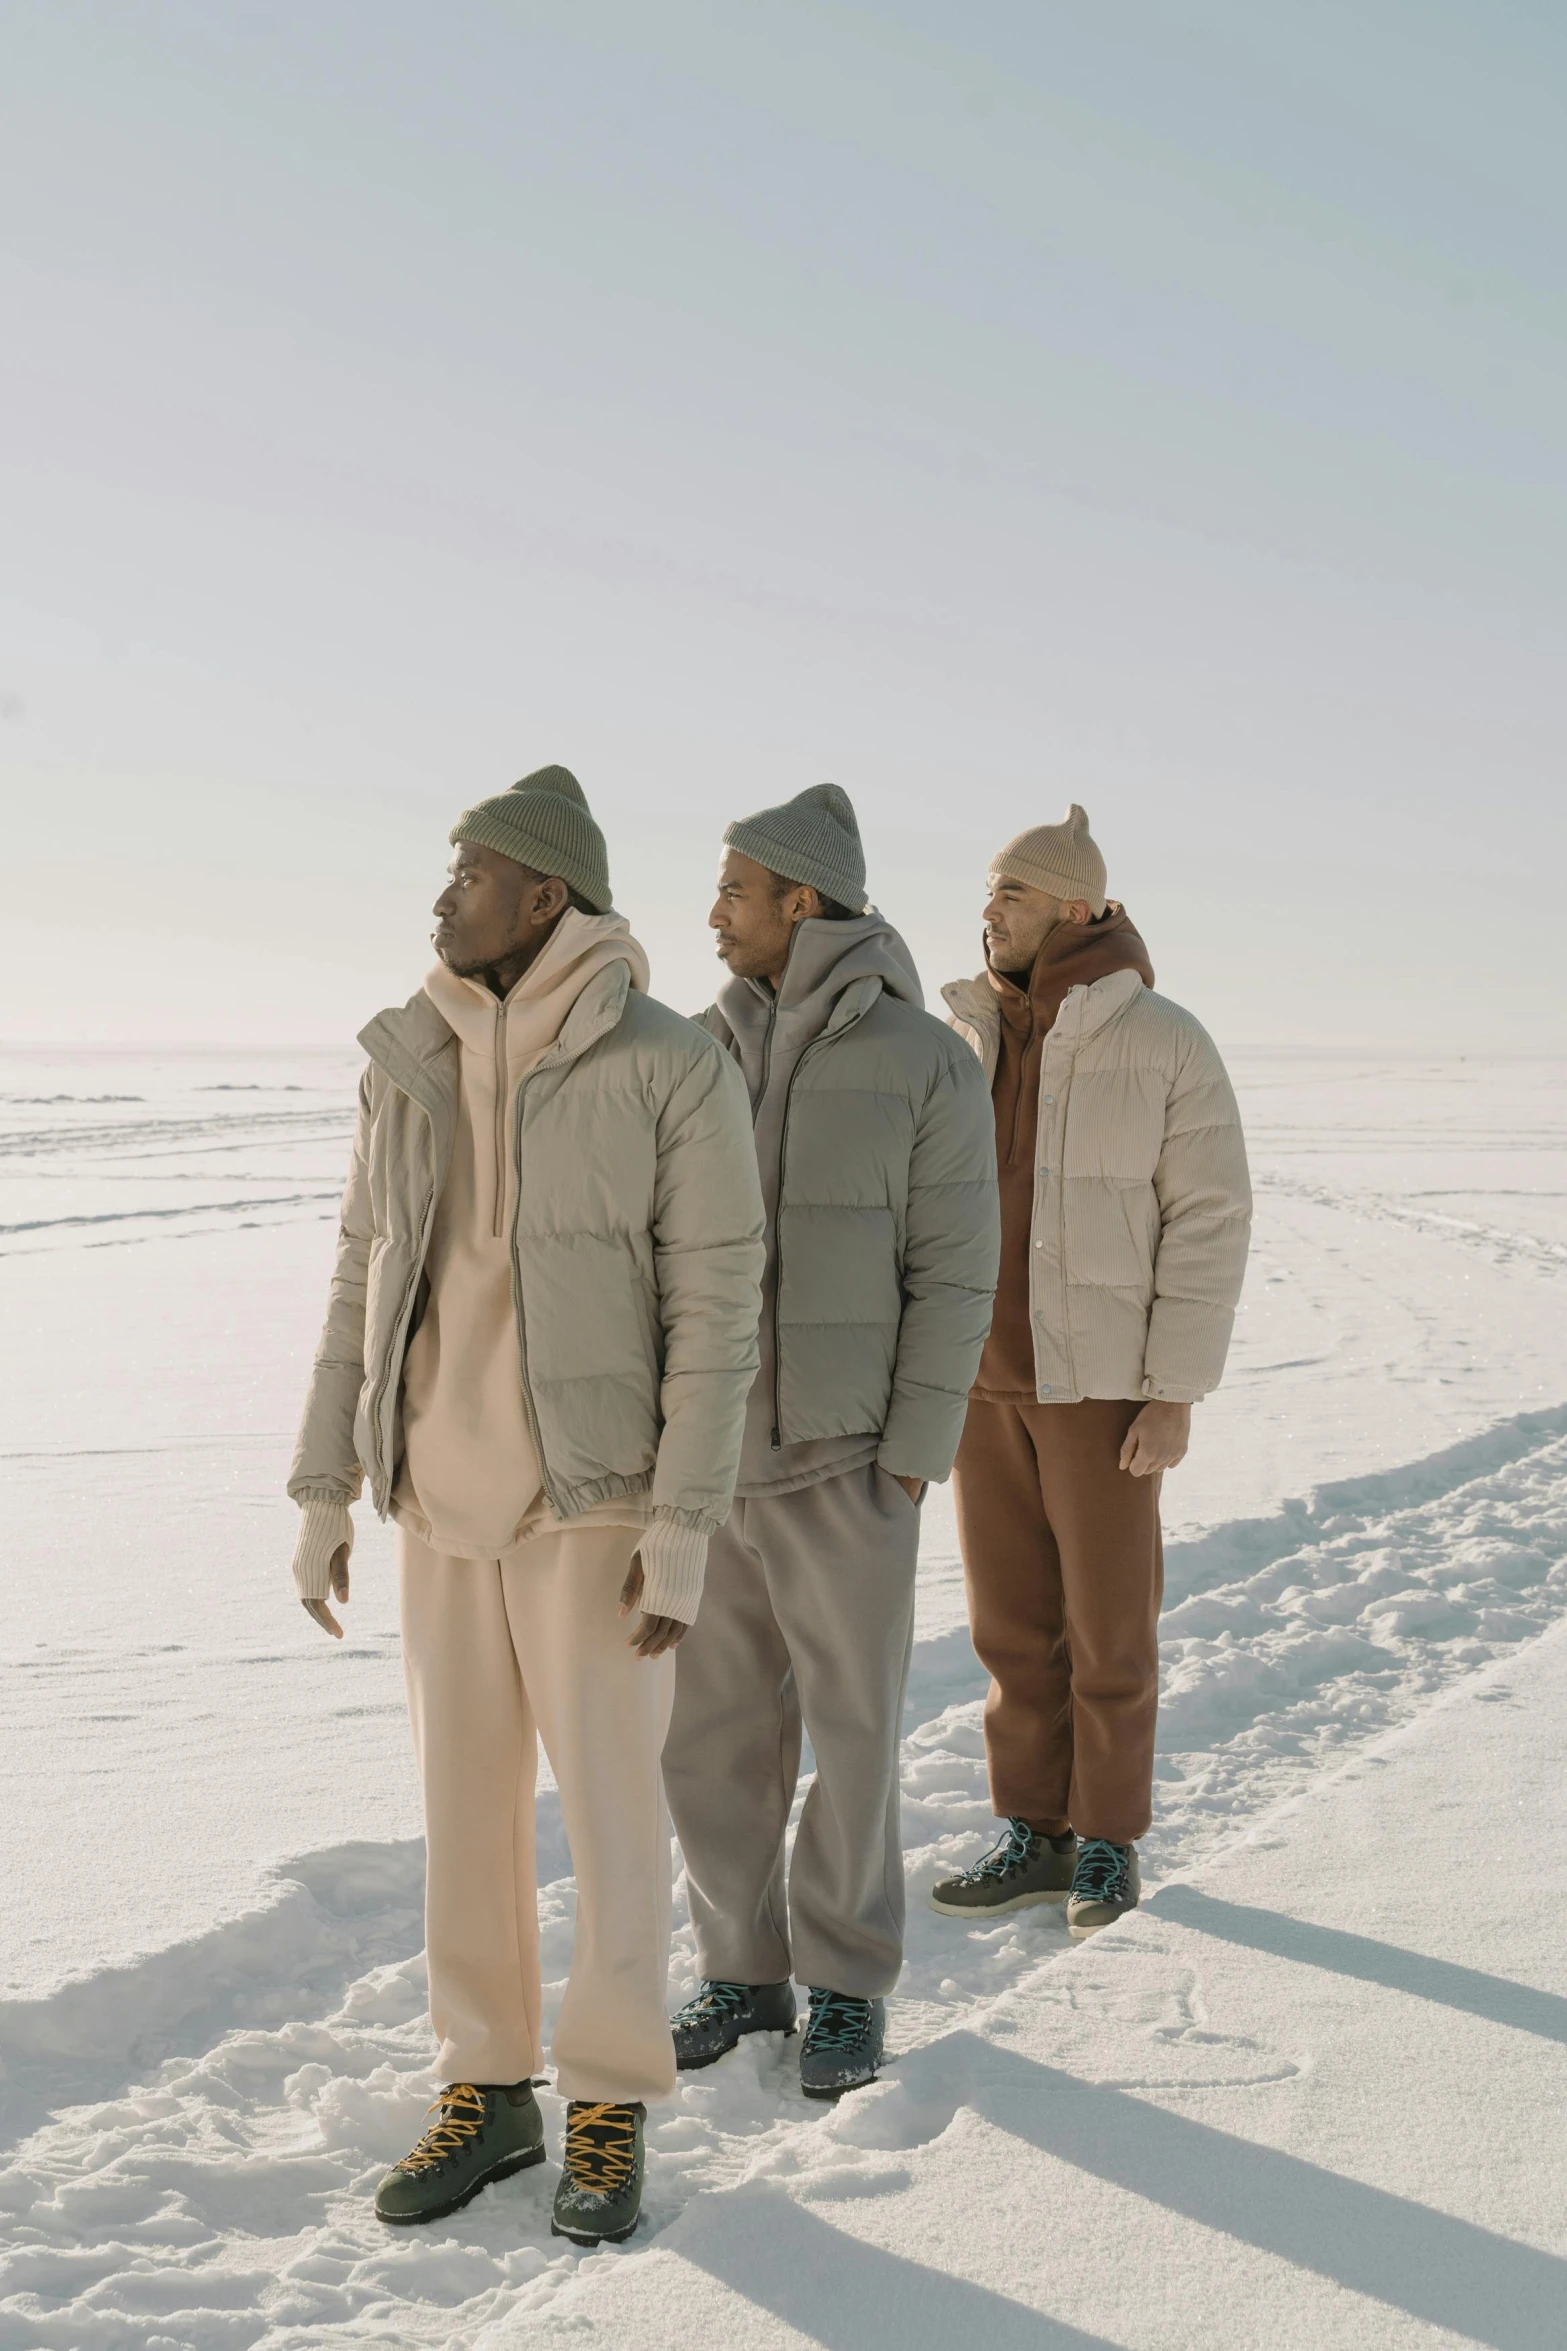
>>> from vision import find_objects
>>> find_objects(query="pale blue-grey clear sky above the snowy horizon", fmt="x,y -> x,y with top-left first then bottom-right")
0,0 -> 1567,1051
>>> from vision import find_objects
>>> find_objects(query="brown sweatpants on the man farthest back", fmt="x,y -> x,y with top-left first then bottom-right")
954,1399 -> 1165,1846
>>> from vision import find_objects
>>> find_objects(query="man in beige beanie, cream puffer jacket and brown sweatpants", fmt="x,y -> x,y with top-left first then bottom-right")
933,806 -> 1252,1937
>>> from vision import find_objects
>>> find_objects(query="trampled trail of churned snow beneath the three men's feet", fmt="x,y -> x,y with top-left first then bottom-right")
0,1408 -> 1567,2351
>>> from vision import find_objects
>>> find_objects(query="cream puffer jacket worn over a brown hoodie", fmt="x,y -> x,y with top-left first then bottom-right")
942,971 -> 1252,1404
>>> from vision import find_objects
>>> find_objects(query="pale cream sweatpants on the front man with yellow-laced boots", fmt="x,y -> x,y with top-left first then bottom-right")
397,1526 -> 674,2102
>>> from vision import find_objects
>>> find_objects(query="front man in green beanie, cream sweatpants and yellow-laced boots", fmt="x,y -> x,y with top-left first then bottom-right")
289,769 -> 761,2243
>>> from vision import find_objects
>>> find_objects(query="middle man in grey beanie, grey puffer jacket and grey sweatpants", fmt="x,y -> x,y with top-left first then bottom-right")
665,783 -> 998,2097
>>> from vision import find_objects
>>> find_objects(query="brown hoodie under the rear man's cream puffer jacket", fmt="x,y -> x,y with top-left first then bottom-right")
973,898 -> 1154,1404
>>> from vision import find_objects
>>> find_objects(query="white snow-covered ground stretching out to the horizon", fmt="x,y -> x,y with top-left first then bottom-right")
0,1053 -> 1567,2351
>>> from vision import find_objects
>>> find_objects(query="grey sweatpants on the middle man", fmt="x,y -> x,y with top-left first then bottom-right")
665,1462 -> 919,1996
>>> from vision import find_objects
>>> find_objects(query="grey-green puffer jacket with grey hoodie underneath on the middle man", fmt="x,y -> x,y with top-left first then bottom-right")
702,912 -> 1001,1491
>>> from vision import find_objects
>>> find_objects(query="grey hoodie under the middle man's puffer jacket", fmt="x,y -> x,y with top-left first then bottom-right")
717,912 -> 923,1495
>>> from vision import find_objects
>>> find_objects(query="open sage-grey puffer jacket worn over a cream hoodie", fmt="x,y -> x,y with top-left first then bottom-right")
289,964 -> 764,1533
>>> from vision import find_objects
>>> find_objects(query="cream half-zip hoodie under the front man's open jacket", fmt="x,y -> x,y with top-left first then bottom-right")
392,907 -> 648,1559
